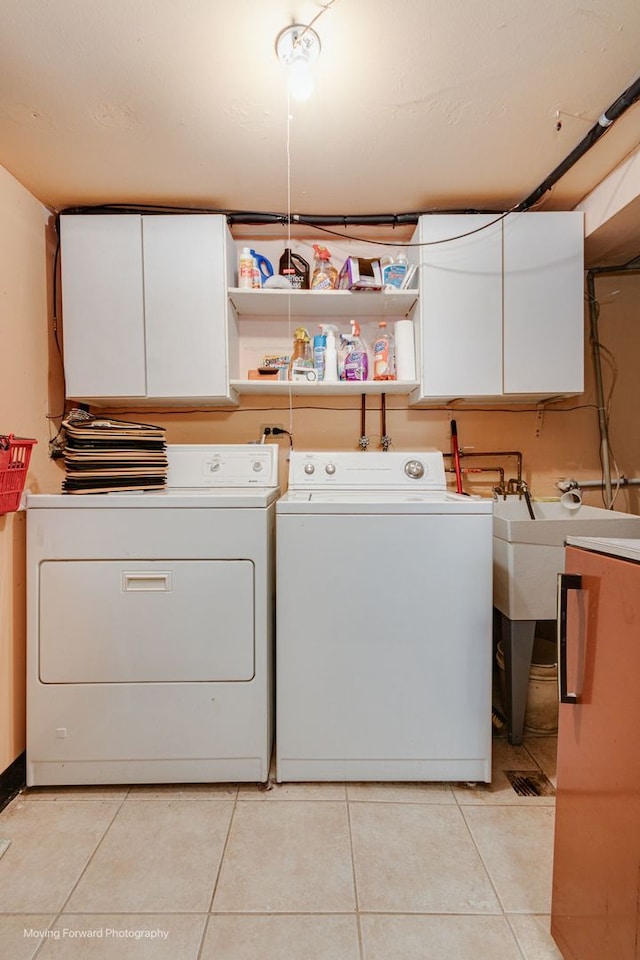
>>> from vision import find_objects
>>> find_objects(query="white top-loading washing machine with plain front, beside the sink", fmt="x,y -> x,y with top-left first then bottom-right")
276,452 -> 493,782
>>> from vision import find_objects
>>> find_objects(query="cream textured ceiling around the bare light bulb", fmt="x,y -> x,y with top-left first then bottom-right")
0,0 -> 640,260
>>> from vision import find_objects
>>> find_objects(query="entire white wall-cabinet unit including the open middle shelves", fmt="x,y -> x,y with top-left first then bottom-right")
60,213 -> 584,406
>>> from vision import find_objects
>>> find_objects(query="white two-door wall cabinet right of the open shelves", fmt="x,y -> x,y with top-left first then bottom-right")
411,212 -> 584,403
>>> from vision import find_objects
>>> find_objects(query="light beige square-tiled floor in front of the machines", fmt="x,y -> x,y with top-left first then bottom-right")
0,738 -> 561,960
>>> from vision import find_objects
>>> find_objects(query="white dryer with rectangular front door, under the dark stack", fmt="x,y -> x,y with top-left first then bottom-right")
27,444 -> 279,786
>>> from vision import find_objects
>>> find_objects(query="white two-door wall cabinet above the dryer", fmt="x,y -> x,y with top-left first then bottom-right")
60,214 -> 232,403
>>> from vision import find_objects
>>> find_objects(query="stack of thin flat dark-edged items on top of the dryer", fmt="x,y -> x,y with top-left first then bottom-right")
62,410 -> 168,493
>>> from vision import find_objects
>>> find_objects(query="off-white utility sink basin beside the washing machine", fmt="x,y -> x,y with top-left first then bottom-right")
493,496 -> 640,620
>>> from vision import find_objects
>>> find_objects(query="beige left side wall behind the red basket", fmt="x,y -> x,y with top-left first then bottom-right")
0,167 -> 59,772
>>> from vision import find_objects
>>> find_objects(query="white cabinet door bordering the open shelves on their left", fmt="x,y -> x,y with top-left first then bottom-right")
142,215 -> 228,398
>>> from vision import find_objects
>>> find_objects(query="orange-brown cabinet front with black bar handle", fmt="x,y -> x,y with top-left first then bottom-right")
551,547 -> 640,960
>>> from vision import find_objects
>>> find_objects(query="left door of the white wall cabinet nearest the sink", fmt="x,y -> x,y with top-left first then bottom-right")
420,214 -> 502,398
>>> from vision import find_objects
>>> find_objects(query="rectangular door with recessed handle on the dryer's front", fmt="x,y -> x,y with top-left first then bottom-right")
38,560 -> 254,683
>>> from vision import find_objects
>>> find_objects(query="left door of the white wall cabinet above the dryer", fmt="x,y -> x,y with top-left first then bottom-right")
60,215 -> 146,399
